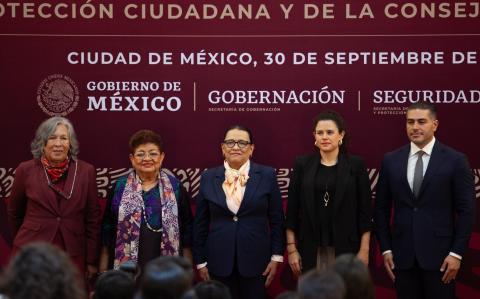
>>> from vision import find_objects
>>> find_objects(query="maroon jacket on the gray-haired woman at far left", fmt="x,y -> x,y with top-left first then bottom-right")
7,159 -> 100,265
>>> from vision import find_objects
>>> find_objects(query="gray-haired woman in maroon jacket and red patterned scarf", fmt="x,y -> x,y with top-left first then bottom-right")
7,117 -> 100,279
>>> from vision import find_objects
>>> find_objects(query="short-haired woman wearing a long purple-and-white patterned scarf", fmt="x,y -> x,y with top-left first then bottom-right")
99,130 -> 192,271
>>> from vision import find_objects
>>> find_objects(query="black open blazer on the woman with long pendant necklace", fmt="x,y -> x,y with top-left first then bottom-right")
286,152 -> 372,271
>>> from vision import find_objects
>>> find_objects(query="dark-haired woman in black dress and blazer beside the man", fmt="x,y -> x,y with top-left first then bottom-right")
286,111 -> 372,275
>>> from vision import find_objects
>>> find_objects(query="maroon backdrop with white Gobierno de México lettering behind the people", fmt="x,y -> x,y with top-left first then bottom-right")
0,1 -> 480,298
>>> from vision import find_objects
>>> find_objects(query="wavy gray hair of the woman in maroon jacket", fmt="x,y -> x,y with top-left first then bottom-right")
30,116 -> 79,160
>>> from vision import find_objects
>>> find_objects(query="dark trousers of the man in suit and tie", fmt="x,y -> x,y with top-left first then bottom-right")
394,261 -> 455,299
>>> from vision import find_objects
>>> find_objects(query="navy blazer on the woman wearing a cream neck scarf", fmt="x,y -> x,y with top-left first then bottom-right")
193,162 -> 285,277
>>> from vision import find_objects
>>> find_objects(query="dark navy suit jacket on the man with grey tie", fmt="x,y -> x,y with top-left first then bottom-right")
375,141 -> 475,271
